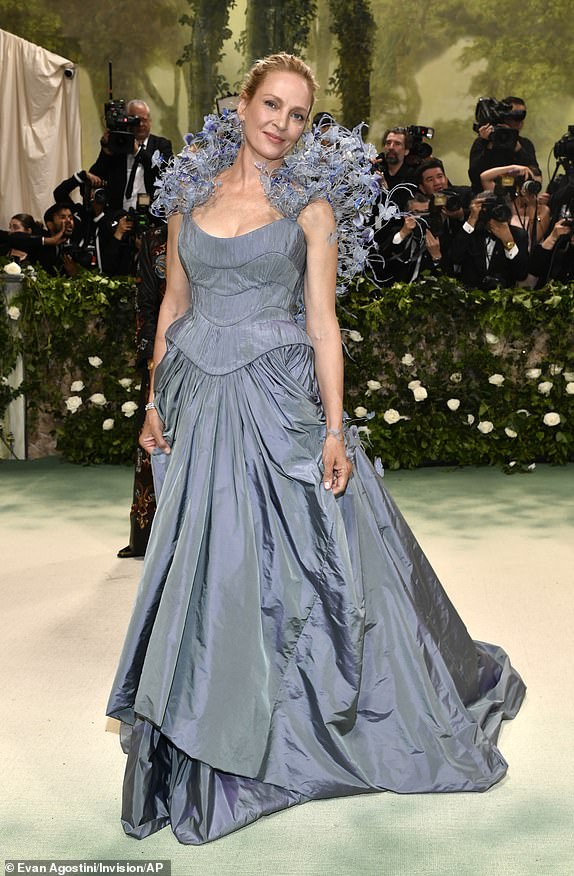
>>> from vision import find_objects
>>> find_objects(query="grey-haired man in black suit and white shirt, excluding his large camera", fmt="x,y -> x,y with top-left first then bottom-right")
90,100 -> 173,212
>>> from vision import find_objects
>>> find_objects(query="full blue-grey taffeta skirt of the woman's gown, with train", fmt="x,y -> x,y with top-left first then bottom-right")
108,345 -> 524,844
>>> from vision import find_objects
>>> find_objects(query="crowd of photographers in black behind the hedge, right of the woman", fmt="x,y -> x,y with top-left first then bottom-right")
366,96 -> 574,290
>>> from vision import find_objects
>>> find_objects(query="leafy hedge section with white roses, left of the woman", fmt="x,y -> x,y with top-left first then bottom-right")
0,268 -> 139,465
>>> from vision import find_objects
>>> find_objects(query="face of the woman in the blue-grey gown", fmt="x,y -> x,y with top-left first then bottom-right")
238,71 -> 312,164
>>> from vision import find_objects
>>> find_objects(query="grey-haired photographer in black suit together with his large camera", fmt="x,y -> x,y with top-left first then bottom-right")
90,100 -> 173,212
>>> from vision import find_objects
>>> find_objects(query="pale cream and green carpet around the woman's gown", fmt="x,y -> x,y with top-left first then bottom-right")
0,459 -> 574,876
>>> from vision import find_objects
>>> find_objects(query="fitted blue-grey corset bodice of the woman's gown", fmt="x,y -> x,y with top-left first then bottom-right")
167,216 -> 310,374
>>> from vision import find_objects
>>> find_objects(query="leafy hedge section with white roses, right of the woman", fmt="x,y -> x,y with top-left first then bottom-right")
340,276 -> 574,471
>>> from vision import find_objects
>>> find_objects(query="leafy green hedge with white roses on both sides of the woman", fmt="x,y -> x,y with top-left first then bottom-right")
0,266 -> 574,471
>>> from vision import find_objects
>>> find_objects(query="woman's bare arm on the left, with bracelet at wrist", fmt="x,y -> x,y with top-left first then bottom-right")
139,213 -> 190,453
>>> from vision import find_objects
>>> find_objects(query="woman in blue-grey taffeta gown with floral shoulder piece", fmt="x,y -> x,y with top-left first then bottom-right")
108,54 -> 524,843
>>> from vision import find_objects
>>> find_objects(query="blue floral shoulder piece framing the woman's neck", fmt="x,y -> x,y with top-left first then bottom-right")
152,110 -> 388,294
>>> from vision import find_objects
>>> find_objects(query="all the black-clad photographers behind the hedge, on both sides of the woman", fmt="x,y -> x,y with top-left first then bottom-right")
0,96 -> 574,289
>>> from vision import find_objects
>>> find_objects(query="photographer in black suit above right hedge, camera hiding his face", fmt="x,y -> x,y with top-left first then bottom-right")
450,190 -> 528,289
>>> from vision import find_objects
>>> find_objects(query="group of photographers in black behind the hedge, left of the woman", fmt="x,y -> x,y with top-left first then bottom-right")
0,100 -> 172,276
